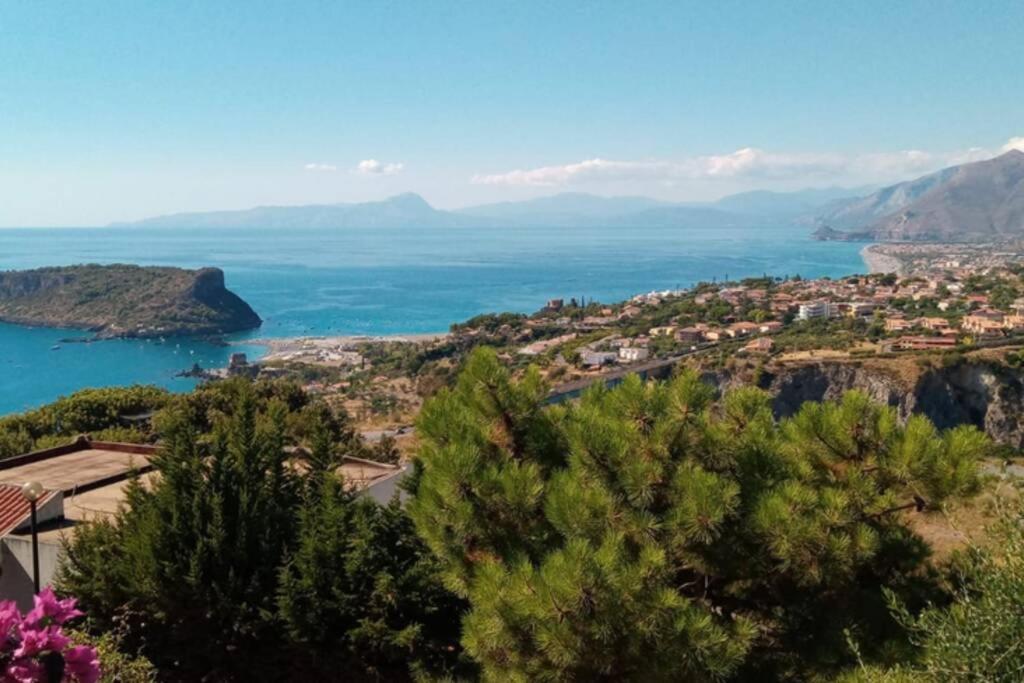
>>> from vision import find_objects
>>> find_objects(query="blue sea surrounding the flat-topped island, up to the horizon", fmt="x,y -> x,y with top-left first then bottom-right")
0,227 -> 863,415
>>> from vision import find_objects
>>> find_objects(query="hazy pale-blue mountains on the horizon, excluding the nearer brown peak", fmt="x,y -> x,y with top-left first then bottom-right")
120,188 -> 862,229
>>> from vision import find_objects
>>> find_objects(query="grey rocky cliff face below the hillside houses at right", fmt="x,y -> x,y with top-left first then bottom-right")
707,358 -> 1024,449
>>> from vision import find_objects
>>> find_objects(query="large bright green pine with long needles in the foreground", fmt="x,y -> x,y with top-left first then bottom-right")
410,350 -> 989,681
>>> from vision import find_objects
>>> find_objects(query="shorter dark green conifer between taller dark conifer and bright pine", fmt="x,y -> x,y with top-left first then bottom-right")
279,475 -> 466,680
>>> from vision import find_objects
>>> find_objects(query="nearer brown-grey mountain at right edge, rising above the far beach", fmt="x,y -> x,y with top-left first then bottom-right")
816,151 -> 1024,242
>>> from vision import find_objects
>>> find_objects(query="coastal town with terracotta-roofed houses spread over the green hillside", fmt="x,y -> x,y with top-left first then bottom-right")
211,244 -> 1024,431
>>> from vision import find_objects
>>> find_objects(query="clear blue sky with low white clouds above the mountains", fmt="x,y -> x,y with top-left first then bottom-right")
0,0 -> 1024,225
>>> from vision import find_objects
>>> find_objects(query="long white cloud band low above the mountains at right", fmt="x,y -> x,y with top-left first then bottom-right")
470,137 -> 1024,186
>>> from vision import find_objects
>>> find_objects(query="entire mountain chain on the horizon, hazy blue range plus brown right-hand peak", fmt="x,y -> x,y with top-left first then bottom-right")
114,151 -> 1024,242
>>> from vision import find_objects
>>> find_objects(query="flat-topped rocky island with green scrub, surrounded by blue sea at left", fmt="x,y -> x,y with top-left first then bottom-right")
0,264 -> 262,338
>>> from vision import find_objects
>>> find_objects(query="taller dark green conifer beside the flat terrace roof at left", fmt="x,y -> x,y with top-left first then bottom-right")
60,391 -> 298,679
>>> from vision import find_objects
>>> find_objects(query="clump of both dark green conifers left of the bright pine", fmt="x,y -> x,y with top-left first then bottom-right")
60,384 -> 460,680
